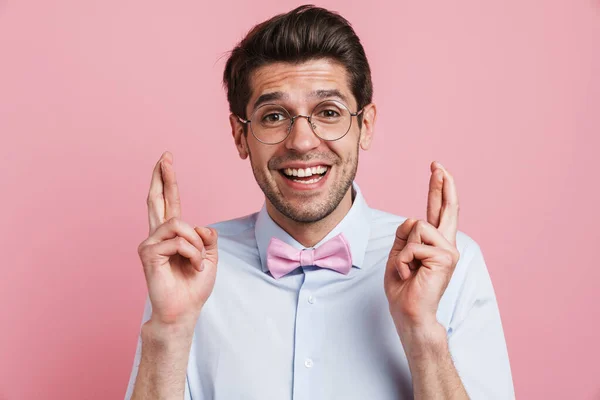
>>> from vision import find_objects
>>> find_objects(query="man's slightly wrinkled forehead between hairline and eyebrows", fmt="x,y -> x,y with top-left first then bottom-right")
247,59 -> 355,110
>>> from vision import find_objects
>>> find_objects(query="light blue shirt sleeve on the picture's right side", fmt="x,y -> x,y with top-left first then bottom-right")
448,240 -> 515,400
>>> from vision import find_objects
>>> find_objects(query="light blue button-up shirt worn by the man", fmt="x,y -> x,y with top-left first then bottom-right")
125,183 -> 514,400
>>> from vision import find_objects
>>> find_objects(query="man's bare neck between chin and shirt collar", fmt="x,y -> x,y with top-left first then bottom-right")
266,187 -> 354,247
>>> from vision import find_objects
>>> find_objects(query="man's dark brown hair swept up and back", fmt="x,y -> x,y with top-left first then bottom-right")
223,5 -> 373,126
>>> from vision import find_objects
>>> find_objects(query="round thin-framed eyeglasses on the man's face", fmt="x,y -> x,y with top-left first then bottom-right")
237,100 -> 364,144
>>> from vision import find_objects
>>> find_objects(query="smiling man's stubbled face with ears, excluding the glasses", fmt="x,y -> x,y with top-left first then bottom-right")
232,59 -> 374,223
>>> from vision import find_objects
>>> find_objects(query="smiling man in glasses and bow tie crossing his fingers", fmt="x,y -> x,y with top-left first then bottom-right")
126,6 -> 514,400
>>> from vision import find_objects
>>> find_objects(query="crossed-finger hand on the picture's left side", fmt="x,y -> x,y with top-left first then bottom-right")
138,152 -> 218,331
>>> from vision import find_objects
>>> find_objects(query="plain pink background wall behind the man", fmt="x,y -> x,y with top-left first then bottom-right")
0,0 -> 600,400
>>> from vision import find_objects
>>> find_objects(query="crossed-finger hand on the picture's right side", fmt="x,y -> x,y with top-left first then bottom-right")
384,162 -> 460,336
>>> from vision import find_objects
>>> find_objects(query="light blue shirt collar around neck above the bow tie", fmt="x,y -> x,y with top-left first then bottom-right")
254,182 -> 371,272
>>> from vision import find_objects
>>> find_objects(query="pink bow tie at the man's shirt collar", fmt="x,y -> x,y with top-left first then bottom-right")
267,233 -> 352,279
